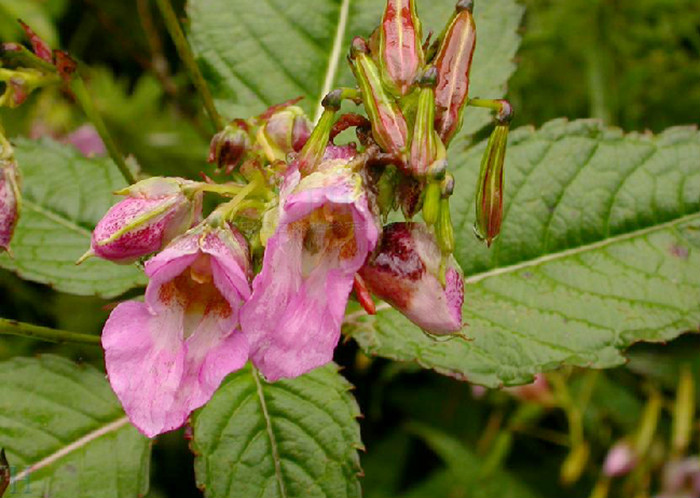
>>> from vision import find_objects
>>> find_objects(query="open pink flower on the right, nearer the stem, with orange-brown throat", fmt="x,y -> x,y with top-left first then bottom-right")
241,147 -> 379,381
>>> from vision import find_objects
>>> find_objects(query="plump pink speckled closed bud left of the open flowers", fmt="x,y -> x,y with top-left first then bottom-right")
85,177 -> 202,263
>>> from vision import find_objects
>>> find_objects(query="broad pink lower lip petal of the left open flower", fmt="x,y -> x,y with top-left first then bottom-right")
102,301 -> 248,437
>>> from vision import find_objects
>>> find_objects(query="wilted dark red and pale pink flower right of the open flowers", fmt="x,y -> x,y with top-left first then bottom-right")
359,223 -> 464,334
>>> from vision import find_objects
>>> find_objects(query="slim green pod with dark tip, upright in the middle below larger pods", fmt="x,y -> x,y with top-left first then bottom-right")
407,67 -> 447,178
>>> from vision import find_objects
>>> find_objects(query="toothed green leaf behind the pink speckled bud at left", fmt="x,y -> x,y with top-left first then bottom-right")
0,140 -> 146,298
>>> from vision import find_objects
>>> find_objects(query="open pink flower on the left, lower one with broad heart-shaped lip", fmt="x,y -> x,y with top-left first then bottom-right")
102,226 -> 250,437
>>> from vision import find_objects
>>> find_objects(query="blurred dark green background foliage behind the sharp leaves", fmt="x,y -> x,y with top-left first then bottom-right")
0,0 -> 700,498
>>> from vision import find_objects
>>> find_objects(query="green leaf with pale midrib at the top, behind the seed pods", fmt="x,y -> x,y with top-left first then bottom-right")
189,0 -> 523,133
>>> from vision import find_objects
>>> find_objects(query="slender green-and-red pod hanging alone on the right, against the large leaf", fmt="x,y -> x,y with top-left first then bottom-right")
474,124 -> 508,246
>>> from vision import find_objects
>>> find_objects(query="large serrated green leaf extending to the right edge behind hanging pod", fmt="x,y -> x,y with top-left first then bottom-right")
347,120 -> 700,387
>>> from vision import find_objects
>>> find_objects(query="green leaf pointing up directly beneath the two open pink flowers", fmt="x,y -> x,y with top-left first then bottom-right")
192,364 -> 362,498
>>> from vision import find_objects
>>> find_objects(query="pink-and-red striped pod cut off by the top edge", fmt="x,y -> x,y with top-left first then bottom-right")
379,0 -> 423,95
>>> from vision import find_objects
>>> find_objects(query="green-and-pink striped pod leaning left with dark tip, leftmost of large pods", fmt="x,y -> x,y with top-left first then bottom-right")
350,38 -> 408,160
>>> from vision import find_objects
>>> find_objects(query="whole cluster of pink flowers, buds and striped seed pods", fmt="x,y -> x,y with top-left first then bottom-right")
75,0 -> 511,436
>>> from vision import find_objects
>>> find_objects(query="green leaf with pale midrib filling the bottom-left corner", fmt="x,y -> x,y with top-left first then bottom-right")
0,356 -> 151,498
